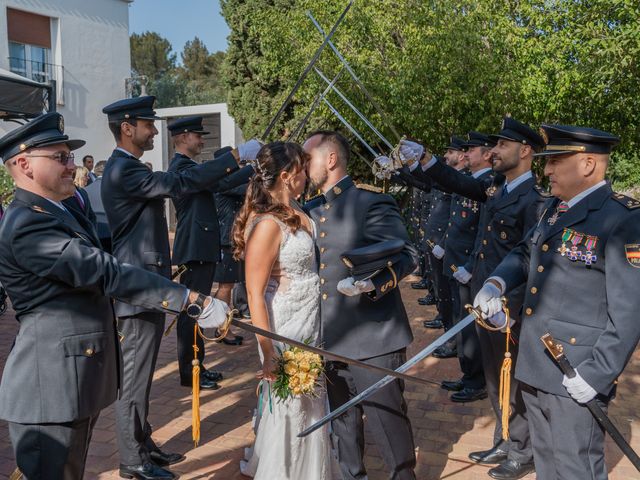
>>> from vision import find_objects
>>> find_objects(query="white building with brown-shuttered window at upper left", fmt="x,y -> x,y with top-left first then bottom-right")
0,0 -> 133,164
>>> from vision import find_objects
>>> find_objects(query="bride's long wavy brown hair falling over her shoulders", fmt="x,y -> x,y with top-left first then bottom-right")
232,142 -> 309,259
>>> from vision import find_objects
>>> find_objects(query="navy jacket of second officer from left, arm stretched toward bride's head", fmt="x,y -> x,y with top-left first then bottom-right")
101,149 -> 238,317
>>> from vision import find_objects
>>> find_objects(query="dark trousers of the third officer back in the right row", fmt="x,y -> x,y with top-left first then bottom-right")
449,278 -> 485,390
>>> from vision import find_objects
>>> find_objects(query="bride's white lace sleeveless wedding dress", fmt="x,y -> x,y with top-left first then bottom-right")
240,215 -> 334,480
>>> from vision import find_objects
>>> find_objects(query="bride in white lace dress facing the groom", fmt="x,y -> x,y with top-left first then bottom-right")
233,142 -> 332,480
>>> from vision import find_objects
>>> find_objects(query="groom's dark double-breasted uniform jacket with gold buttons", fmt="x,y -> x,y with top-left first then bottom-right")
305,177 -> 417,359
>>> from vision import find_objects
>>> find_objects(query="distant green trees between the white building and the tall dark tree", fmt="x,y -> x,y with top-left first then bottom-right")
131,32 -> 226,108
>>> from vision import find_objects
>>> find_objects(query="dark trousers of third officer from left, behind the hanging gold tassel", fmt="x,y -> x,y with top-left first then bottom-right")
176,262 -> 216,385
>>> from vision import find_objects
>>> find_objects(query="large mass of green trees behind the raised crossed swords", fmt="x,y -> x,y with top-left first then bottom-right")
221,0 -> 640,186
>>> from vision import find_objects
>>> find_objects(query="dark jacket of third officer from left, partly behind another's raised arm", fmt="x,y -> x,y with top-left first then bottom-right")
167,152 -> 254,265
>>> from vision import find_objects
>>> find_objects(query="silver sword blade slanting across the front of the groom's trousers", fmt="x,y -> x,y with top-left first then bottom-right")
298,314 -> 476,437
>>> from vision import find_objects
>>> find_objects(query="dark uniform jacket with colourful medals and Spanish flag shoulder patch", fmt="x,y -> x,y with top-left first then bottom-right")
493,185 -> 640,397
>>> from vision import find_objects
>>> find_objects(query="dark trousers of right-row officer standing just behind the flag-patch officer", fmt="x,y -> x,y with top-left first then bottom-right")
476,319 -> 532,464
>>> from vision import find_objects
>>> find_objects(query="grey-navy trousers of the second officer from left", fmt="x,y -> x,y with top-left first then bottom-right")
115,312 -> 165,465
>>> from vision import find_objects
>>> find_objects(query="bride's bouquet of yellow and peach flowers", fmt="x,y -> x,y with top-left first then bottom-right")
273,347 -> 324,400
